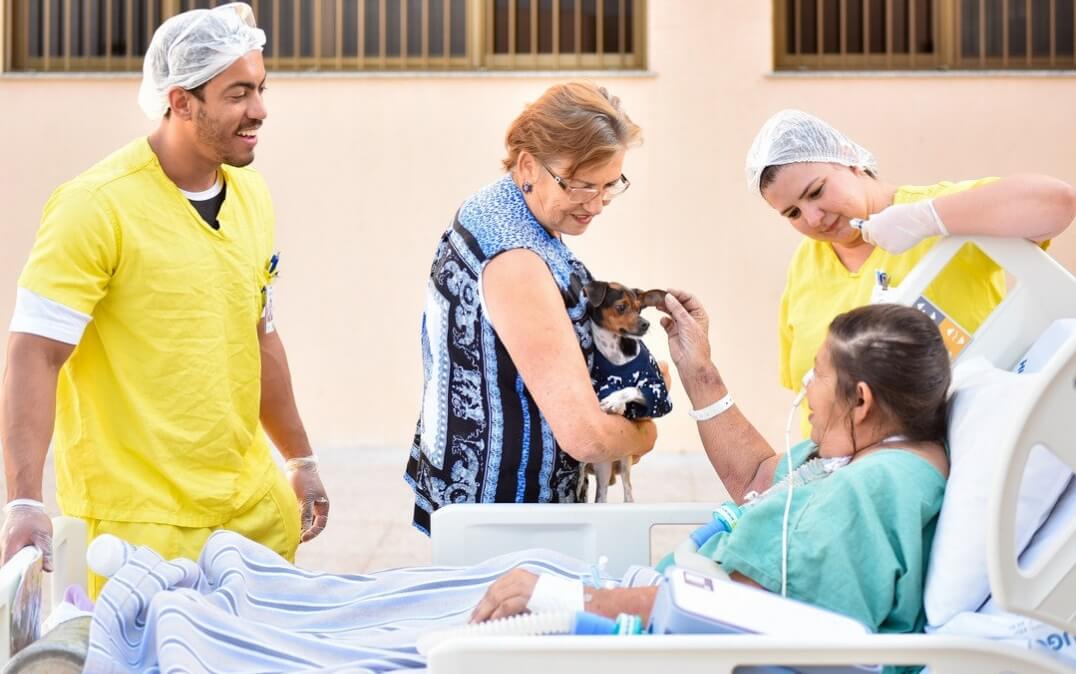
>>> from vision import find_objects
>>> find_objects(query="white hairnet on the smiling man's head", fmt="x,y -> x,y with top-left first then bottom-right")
138,2 -> 266,121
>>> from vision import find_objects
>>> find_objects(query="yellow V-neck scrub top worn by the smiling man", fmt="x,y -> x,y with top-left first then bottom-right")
18,138 -> 277,526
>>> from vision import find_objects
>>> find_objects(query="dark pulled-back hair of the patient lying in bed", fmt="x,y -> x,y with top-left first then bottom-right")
829,304 -> 950,443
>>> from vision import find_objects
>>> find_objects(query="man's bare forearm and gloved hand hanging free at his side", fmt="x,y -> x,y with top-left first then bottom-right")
258,321 -> 329,543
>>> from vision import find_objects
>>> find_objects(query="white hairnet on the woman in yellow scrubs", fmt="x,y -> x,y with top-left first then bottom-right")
744,110 -> 878,194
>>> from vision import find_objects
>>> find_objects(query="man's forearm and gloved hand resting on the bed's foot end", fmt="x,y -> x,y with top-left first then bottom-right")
0,333 -> 74,571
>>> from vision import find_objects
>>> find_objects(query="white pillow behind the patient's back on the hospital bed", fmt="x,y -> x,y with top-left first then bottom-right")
923,359 -> 1072,629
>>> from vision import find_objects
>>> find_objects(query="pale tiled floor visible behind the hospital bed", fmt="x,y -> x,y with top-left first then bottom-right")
12,449 -> 727,573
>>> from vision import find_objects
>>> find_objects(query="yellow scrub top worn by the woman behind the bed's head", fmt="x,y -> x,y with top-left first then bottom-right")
778,178 -> 1005,436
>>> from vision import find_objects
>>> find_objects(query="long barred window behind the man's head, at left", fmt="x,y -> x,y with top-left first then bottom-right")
0,0 -> 646,72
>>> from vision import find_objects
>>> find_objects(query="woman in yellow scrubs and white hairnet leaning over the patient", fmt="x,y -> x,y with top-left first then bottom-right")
746,110 -> 1076,430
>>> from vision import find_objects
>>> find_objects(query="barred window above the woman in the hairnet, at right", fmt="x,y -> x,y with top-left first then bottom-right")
774,0 -> 1076,70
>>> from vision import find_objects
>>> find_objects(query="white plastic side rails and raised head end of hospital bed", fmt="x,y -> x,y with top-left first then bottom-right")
429,237 -> 1076,674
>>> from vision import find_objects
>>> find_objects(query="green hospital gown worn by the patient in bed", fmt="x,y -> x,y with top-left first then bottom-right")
699,441 -> 945,633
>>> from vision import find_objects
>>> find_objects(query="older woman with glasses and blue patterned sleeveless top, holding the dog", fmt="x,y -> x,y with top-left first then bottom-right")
407,83 -> 656,533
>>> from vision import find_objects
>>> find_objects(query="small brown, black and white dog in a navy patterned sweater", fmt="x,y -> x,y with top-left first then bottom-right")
580,281 -> 673,503
